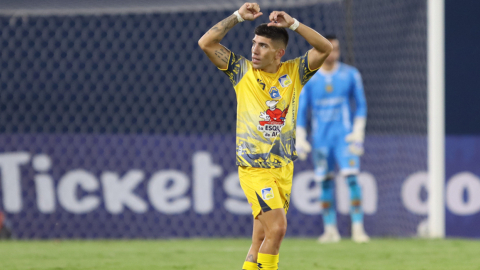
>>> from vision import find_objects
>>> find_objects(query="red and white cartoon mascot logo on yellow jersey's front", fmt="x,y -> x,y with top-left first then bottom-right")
257,100 -> 288,138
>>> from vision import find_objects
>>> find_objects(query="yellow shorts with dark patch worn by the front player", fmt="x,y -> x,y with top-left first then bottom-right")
238,162 -> 293,218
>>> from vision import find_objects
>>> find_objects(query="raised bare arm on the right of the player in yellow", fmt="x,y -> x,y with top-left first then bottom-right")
268,11 -> 333,70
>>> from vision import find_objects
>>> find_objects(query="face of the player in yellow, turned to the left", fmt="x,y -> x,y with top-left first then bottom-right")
252,35 -> 281,69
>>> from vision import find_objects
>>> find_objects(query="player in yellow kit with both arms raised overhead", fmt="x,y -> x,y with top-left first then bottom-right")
198,3 -> 332,270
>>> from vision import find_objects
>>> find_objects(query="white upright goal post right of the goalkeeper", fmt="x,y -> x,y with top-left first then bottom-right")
427,0 -> 445,238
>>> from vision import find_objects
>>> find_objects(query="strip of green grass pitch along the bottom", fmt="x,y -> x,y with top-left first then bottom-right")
0,238 -> 480,270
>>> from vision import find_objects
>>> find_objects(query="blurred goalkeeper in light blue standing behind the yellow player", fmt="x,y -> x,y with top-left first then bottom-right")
297,35 -> 369,243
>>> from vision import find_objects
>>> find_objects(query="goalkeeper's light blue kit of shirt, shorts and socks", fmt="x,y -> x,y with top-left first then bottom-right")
297,62 -> 367,225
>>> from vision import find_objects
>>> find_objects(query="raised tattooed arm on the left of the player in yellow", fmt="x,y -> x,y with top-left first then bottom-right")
198,3 -> 263,69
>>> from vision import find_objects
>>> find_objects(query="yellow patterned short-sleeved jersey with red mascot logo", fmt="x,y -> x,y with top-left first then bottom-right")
220,52 -> 318,168
